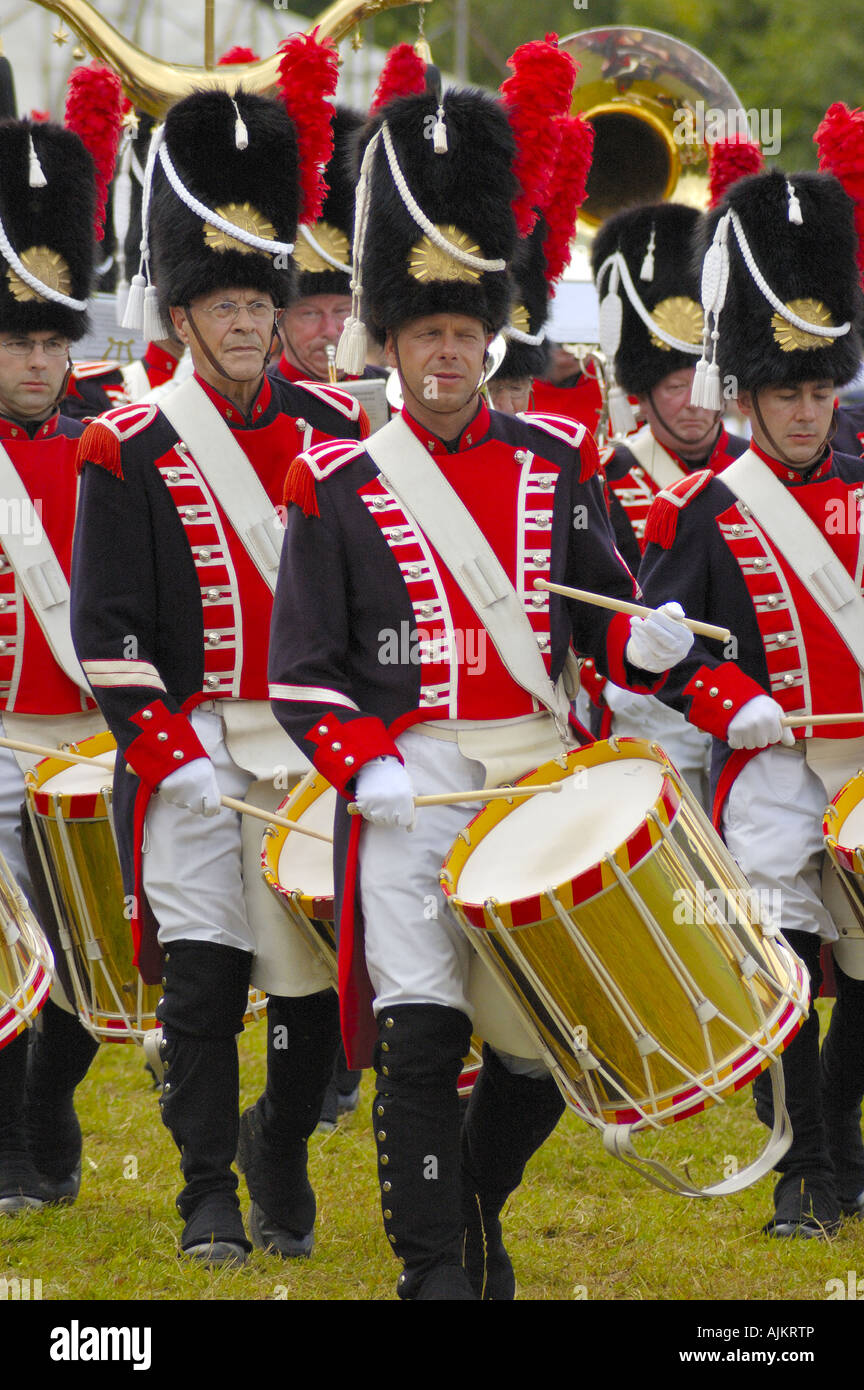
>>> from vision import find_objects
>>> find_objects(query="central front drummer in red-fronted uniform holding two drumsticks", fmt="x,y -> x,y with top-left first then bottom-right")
271,46 -> 690,1300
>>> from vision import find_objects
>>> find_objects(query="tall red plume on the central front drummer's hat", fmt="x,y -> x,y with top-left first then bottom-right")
501,33 -> 576,236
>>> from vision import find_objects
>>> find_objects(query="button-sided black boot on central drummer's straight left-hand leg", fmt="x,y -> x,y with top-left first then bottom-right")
372,1004 -> 476,1301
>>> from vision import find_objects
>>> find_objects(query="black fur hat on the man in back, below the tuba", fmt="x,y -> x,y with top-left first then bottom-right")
592,203 -> 703,396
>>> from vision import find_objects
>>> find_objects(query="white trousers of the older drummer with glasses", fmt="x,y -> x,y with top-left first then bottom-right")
142,709 -> 332,997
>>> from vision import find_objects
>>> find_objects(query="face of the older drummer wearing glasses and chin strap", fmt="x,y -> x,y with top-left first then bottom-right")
171,288 -> 275,391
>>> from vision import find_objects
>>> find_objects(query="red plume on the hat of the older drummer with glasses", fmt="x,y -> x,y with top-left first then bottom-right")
279,29 -> 339,225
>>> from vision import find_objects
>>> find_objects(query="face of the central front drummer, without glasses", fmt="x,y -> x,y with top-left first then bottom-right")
385,314 -> 490,416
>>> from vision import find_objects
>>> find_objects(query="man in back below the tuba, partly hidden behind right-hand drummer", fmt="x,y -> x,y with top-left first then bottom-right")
583,203 -> 746,805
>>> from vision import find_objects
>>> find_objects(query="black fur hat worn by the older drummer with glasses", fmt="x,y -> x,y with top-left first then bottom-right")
149,88 -> 300,320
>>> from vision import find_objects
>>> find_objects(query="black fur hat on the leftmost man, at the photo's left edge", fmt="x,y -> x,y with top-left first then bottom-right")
0,121 -> 96,342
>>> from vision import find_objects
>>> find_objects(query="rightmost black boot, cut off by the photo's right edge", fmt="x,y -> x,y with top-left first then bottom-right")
821,959 -> 864,1216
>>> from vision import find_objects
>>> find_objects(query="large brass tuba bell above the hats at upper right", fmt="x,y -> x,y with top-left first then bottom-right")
560,26 -> 742,227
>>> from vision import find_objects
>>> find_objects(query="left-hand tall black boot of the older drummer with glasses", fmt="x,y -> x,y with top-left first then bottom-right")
157,941 -> 251,1265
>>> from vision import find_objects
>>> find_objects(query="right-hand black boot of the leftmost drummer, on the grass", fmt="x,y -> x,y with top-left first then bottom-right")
26,999 -> 99,1205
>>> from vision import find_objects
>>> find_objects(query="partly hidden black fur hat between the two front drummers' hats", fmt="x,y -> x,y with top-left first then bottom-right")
294,106 -> 365,299
